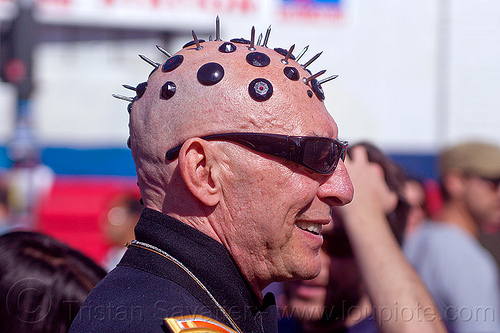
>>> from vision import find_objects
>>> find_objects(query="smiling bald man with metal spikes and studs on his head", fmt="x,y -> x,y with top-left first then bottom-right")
71,20 -> 353,332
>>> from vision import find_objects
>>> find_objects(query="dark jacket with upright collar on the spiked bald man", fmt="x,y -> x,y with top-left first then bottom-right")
70,208 -> 277,333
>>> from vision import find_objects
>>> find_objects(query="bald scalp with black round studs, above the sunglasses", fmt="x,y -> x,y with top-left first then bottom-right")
130,35 -> 338,208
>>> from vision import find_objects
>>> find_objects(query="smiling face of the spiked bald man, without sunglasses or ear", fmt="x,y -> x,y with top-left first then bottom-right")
217,103 -> 353,288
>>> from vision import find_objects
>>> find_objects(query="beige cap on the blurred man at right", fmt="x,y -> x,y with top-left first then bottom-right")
439,141 -> 500,178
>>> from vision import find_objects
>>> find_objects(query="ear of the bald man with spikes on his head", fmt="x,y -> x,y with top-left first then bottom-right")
178,138 -> 221,207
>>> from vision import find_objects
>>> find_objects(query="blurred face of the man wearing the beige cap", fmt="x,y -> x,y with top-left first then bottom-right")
465,176 -> 500,225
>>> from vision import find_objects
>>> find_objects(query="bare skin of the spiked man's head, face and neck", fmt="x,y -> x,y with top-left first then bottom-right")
130,42 -> 353,296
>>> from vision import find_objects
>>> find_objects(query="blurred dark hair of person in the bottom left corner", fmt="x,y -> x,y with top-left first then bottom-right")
0,231 -> 106,333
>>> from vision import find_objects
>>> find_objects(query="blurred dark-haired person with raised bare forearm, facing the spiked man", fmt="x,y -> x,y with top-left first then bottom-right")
280,143 -> 445,333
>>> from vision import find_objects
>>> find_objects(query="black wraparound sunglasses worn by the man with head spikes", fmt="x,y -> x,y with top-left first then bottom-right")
166,133 -> 348,174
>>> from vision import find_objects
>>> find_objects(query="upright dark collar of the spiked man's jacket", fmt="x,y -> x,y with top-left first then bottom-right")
135,208 -> 277,332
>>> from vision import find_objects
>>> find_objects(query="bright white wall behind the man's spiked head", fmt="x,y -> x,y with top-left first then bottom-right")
0,0 -> 500,152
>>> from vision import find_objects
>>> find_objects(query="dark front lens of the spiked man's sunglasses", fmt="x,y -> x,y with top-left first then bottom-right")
302,139 -> 340,173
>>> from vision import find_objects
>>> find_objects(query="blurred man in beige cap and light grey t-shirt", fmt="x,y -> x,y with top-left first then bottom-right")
404,142 -> 500,332
